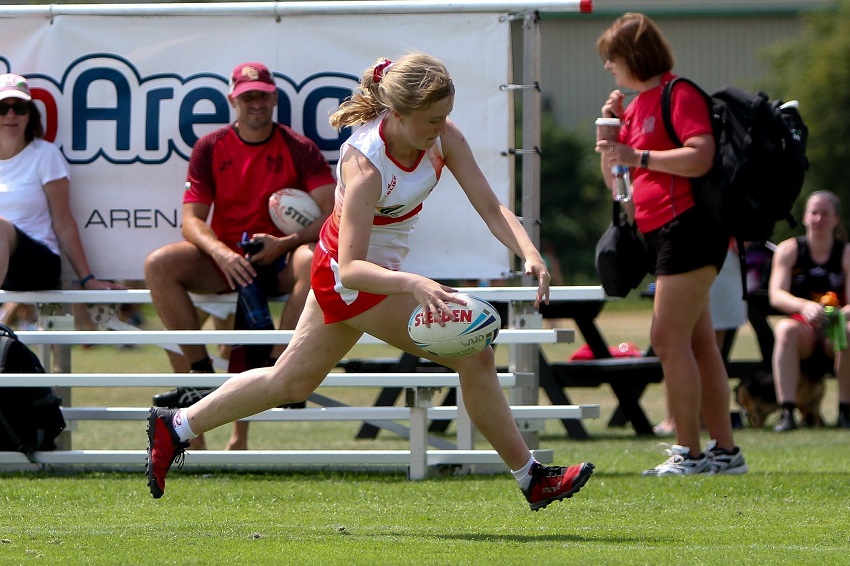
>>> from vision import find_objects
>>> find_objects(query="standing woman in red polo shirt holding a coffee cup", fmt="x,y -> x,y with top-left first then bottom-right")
596,13 -> 747,476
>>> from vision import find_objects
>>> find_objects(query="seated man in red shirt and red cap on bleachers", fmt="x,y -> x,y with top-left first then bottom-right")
145,63 -> 336,449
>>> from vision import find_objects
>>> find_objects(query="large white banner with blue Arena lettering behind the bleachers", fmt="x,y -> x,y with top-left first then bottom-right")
0,13 -> 514,279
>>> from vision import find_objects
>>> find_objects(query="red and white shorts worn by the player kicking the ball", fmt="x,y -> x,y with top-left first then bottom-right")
310,242 -> 387,324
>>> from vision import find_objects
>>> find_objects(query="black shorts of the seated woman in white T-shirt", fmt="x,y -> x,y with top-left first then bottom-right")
2,226 -> 62,291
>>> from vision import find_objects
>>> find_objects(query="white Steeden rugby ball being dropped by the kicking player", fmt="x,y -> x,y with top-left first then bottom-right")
407,295 -> 502,358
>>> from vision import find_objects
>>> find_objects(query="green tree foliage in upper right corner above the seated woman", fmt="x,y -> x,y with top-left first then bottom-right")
764,0 -> 850,241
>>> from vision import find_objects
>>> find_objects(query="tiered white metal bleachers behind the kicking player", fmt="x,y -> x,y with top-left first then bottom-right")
0,287 -> 601,479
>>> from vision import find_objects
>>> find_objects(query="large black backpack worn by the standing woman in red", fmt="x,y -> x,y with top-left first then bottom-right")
661,77 -> 809,242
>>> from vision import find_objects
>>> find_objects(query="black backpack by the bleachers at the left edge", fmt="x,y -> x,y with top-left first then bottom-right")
0,324 -> 65,462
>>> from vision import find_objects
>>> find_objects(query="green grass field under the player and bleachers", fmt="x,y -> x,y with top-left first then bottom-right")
0,310 -> 850,565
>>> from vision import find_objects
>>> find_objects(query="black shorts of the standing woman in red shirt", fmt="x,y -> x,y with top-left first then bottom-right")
644,206 -> 729,275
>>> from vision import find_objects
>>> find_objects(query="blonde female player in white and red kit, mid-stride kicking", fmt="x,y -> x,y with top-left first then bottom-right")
147,53 -> 593,510
